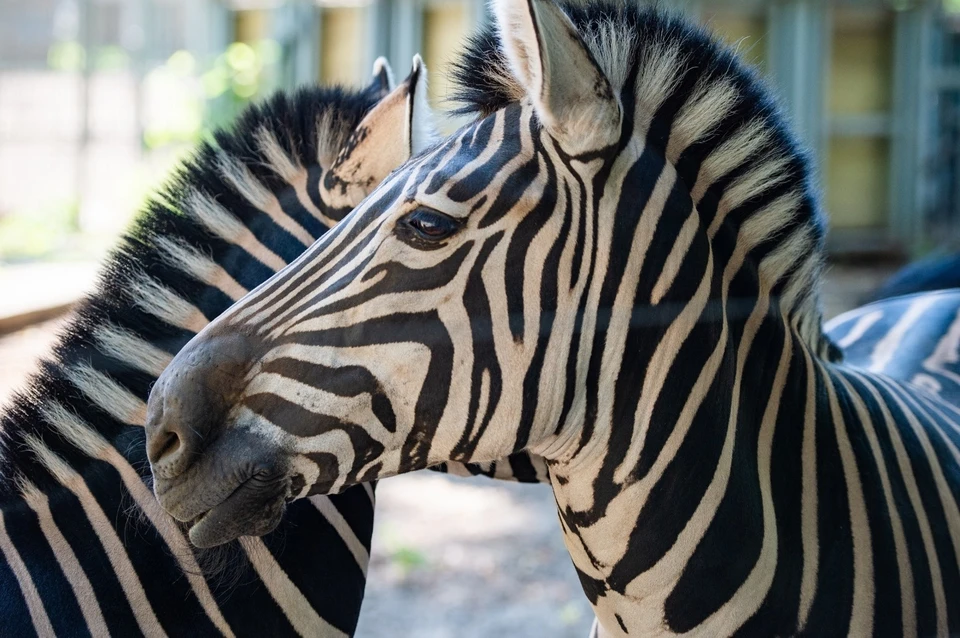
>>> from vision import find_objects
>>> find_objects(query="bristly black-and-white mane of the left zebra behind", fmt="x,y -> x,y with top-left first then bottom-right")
0,82 -> 376,494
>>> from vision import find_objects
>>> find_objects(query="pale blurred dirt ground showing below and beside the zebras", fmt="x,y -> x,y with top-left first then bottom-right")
0,267 -> 890,638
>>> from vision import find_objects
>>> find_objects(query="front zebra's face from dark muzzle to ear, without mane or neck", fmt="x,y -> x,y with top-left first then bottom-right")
142,0 -> 636,533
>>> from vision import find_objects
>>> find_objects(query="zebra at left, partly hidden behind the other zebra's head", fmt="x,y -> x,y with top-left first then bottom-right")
0,58 -> 430,637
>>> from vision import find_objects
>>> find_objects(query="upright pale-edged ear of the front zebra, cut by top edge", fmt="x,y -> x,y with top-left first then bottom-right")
493,0 -> 621,154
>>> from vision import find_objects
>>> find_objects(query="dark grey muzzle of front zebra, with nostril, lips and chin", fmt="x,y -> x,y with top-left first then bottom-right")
146,335 -> 291,547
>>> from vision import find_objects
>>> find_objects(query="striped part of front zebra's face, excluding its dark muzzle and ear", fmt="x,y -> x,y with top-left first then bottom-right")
246,100 -> 604,480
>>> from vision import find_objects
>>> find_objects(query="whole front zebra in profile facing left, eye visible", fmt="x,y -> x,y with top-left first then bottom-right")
146,0 -> 960,636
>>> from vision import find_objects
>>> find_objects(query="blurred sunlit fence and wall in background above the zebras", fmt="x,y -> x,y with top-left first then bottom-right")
0,0 -> 960,262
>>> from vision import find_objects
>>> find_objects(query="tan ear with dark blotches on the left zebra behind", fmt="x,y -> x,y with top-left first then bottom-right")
326,56 -> 434,205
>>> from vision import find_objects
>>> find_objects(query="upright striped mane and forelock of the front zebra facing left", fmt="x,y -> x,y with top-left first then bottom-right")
452,0 -> 836,358
